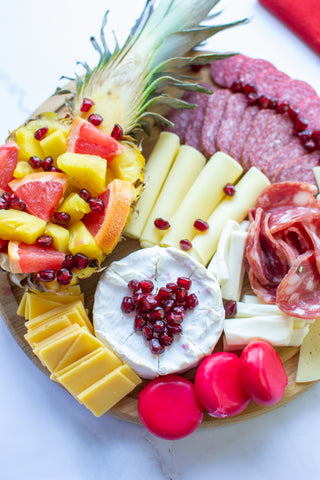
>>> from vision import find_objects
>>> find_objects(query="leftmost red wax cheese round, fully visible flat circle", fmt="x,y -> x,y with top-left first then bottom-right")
138,375 -> 203,440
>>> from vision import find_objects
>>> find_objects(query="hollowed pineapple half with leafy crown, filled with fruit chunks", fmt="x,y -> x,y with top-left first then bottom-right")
0,0 -> 245,290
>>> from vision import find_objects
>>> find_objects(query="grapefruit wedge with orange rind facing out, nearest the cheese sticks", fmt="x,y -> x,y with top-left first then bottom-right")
82,179 -> 132,254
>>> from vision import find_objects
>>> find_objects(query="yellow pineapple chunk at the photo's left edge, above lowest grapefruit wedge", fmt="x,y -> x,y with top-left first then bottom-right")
0,209 -> 46,244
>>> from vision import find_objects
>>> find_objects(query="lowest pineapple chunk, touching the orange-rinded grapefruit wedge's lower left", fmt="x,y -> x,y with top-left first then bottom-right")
69,220 -> 104,261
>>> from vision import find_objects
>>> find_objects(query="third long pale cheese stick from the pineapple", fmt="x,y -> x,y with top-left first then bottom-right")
160,152 -> 243,248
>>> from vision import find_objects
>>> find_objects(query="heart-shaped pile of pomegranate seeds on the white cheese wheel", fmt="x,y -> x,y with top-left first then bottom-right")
121,277 -> 198,355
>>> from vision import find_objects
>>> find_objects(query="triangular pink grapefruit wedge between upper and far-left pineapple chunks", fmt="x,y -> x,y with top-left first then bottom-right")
9,172 -> 69,222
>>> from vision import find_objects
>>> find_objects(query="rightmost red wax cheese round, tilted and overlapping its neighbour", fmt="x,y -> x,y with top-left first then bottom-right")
240,341 -> 288,406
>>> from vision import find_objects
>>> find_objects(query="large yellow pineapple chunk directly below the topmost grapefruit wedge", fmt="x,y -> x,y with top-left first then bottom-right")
57,152 -> 107,195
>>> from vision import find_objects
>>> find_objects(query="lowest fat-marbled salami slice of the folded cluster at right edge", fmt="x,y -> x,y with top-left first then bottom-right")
276,251 -> 320,319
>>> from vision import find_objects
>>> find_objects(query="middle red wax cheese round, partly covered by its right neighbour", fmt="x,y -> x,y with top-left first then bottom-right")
195,352 -> 250,418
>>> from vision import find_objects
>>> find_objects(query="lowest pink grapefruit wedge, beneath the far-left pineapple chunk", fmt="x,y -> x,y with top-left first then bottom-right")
8,241 -> 65,273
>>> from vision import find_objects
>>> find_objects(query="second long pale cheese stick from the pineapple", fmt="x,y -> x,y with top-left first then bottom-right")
140,145 -> 206,248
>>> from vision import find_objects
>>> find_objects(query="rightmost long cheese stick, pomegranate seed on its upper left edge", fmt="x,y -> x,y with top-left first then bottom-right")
190,167 -> 270,265
